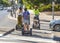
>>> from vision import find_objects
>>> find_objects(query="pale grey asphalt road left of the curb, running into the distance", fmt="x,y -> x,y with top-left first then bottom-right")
0,10 -> 16,28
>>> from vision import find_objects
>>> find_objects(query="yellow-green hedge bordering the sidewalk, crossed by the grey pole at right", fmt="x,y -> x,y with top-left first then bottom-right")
39,4 -> 60,11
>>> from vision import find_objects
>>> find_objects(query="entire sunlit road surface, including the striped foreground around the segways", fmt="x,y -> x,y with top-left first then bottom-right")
0,10 -> 60,43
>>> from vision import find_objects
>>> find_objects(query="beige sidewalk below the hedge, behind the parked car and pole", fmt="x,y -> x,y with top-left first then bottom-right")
40,12 -> 60,21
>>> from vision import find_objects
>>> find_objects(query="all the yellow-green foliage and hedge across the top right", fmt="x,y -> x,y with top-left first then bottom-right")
23,0 -> 60,11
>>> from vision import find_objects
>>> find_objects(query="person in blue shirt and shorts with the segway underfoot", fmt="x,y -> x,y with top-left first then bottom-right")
22,8 -> 32,35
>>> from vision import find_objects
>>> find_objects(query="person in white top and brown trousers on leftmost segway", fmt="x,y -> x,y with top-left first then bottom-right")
16,7 -> 23,30
